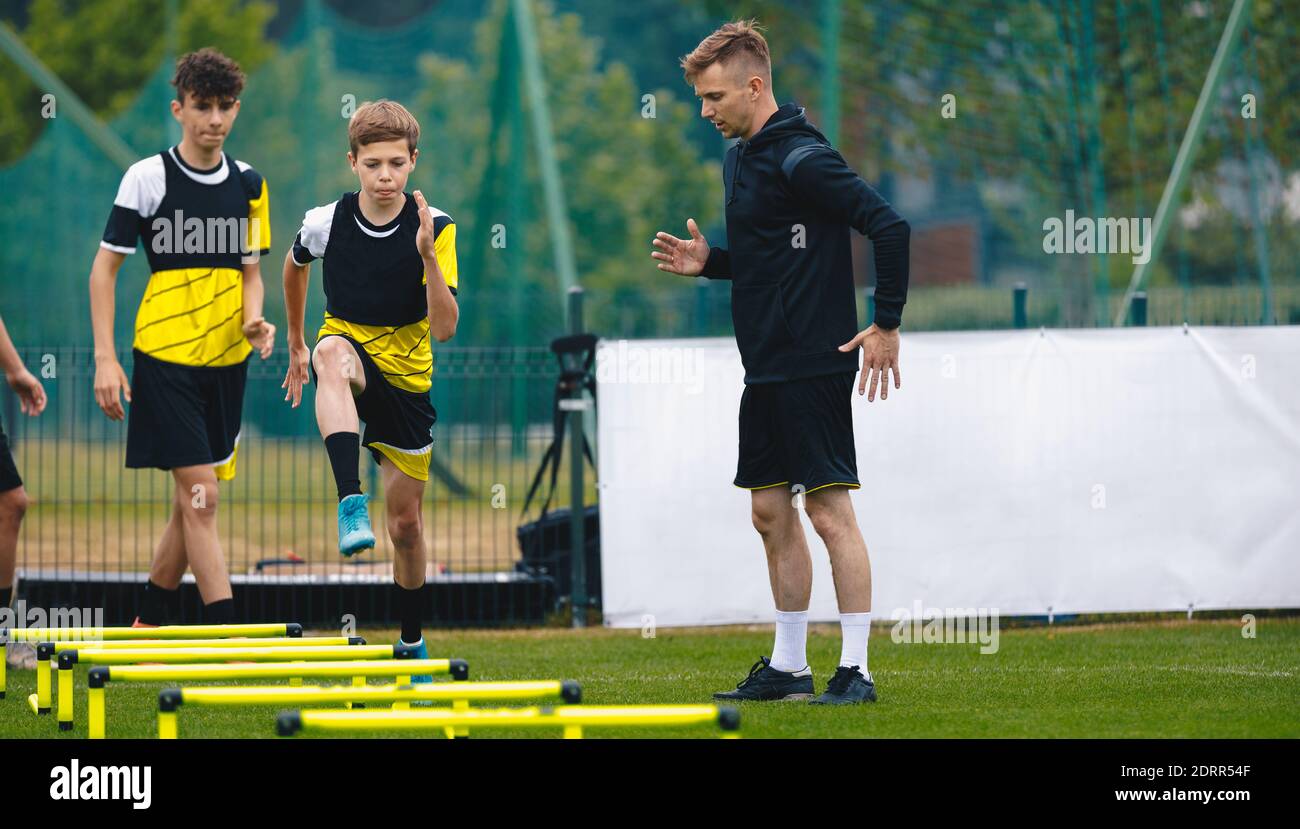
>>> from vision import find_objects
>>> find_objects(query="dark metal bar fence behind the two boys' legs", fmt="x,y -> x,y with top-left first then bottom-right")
4,347 -> 594,625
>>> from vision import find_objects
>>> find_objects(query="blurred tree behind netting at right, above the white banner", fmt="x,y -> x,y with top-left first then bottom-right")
705,0 -> 1300,324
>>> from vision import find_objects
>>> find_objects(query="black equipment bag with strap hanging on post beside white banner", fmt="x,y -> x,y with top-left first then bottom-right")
515,334 -> 601,607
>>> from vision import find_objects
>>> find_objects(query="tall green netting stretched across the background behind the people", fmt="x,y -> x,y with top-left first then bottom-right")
0,0 -> 1300,347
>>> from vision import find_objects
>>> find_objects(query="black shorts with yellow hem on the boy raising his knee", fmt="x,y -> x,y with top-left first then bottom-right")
312,334 -> 438,481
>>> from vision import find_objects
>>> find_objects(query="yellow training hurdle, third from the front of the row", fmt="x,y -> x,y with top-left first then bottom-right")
87,659 -> 469,739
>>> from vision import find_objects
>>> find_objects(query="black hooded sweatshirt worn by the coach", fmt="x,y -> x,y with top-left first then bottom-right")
702,103 -> 910,383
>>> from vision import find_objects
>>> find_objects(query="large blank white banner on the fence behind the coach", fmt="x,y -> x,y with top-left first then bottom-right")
597,326 -> 1300,626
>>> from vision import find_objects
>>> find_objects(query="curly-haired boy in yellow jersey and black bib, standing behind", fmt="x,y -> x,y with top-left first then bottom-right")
90,49 -> 276,626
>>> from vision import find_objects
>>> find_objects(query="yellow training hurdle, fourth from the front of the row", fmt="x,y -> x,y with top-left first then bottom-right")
55,642 -> 415,732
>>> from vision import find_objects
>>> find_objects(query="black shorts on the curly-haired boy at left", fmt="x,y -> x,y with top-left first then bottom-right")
126,351 -> 248,481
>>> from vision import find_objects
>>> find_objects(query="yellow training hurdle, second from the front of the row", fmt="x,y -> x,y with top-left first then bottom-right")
159,680 -> 582,739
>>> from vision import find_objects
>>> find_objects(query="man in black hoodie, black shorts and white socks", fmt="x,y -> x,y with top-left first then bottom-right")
651,22 -> 910,704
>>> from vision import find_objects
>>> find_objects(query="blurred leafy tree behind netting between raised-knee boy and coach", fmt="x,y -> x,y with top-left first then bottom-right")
416,3 -> 722,343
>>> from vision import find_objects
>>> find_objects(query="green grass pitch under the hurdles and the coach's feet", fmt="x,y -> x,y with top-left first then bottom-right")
0,617 -> 1300,739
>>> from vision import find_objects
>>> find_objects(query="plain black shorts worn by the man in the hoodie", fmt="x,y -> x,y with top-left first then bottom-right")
735,372 -> 858,492
